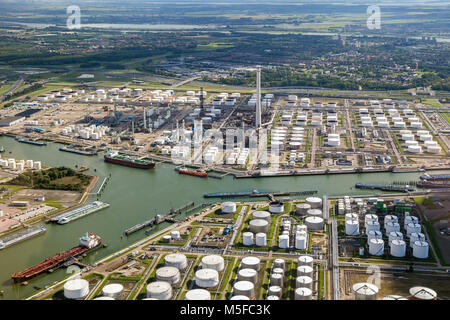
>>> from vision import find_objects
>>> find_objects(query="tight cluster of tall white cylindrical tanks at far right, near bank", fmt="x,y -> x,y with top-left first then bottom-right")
338,196 -> 429,259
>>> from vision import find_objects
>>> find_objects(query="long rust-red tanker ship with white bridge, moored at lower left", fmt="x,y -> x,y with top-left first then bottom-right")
11,234 -> 102,282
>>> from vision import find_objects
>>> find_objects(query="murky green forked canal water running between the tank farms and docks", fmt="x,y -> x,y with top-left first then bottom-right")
0,137 -> 444,299
